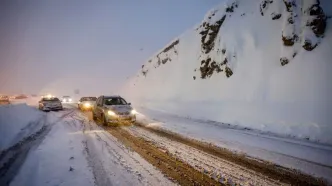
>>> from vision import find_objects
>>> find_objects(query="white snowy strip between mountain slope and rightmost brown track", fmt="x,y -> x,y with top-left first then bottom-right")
136,108 -> 332,183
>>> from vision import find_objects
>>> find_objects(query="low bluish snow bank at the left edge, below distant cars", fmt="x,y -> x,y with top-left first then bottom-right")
0,104 -> 44,151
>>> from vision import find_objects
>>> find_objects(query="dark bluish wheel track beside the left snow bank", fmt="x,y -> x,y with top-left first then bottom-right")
0,111 -> 73,185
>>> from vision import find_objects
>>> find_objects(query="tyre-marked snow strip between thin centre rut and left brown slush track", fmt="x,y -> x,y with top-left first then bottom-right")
73,112 -> 171,185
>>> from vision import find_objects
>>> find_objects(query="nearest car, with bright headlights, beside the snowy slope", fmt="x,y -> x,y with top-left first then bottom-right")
92,96 -> 136,125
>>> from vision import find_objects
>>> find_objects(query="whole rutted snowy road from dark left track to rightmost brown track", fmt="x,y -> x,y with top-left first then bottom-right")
0,105 -> 326,186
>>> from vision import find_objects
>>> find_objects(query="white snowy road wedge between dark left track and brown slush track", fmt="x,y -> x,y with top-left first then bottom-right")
11,109 -> 173,186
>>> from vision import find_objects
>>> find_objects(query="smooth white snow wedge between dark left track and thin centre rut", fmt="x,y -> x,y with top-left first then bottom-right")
11,112 -> 94,186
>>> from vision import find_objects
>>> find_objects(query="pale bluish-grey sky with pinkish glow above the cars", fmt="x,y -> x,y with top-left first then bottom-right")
0,0 -> 222,95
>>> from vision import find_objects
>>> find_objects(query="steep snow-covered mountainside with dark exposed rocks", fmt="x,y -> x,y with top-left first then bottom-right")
121,0 -> 332,144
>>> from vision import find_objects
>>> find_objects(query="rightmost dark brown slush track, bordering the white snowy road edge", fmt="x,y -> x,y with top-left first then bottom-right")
135,122 -> 327,185
